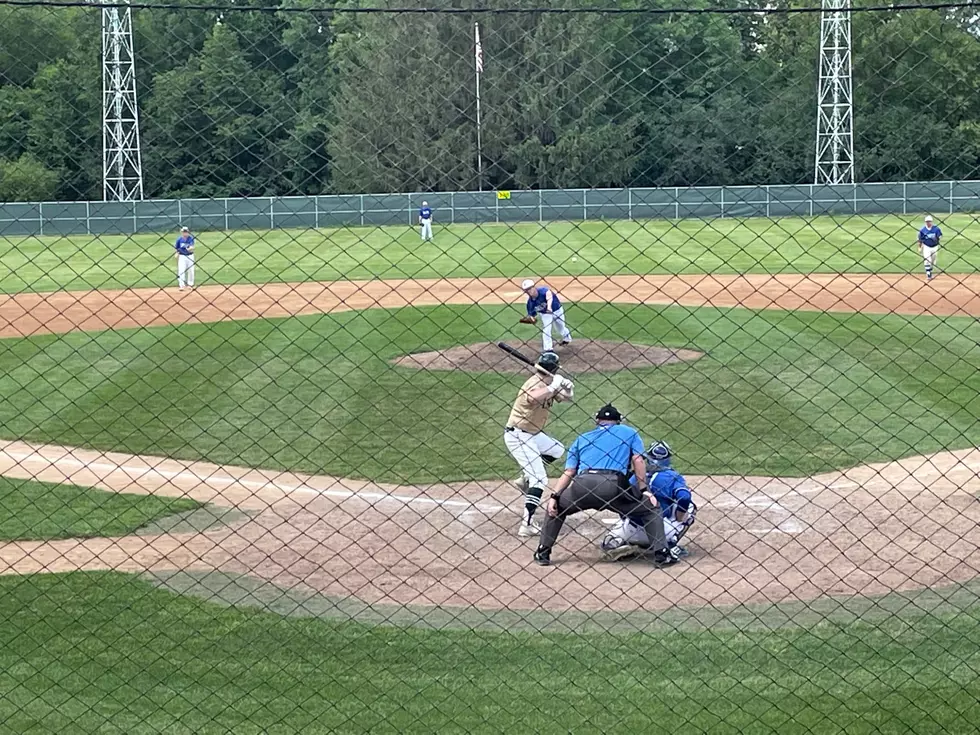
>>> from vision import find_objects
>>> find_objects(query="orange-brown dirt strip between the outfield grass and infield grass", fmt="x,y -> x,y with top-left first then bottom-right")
0,274 -> 980,337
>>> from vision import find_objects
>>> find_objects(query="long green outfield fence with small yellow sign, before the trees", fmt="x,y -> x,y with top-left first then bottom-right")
0,181 -> 980,237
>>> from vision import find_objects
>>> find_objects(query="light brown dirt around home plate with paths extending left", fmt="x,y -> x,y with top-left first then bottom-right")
0,442 -> 980,611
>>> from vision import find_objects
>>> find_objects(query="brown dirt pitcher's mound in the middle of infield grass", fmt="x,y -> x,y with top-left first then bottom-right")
392,339 -> 703,374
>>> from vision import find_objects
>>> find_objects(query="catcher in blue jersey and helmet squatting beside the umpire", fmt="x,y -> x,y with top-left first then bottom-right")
600,441 -> 698,559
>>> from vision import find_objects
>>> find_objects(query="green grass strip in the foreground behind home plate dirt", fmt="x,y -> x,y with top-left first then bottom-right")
0,573 -> 980,735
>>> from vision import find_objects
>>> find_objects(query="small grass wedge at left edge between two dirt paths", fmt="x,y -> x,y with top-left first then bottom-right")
0,477 -> 201,541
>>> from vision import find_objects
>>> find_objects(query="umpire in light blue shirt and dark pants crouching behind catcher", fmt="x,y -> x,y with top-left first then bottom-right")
534,404 -> 678,566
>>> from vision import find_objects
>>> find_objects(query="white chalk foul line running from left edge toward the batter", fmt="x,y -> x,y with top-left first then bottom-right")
2,451 -> 507,515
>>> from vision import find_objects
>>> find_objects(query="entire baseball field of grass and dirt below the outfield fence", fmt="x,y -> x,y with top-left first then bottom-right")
0,215 -> 980,733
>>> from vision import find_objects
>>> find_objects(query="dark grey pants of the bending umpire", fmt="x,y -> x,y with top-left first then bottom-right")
539,471 -> 667,551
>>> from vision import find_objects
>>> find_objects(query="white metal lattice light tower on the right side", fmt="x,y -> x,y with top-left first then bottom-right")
814,0 -> 854,184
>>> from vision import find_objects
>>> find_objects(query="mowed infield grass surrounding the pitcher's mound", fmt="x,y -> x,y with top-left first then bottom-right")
0,304 -> 980,482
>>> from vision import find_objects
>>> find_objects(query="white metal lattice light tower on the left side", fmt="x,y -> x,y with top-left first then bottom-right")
102,4 -> 143,202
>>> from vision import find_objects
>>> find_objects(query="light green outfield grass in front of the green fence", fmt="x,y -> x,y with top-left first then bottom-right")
0,214 -> 980,293
